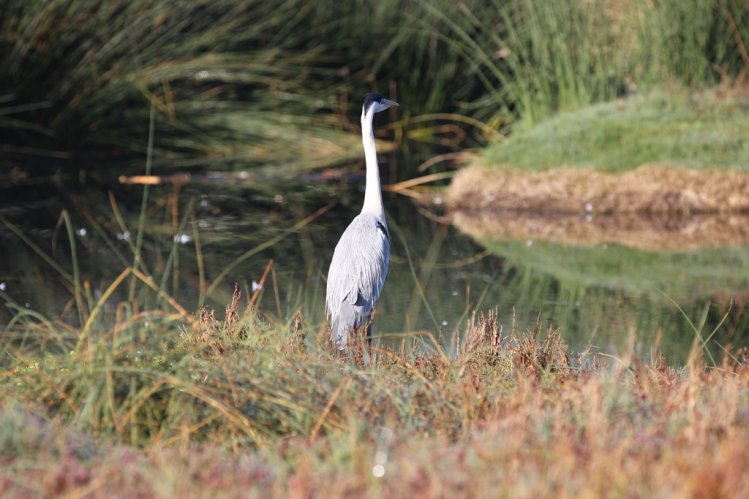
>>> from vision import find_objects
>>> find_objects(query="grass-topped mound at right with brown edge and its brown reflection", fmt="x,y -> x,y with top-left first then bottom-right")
447,88 -> 749,250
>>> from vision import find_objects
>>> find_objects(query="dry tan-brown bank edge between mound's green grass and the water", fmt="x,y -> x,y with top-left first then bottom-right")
447,165 -> 749,214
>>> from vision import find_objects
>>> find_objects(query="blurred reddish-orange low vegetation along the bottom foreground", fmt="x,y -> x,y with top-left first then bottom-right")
0,366 -> 749,497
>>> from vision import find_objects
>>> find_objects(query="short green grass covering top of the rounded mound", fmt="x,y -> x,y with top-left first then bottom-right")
482,88 -> 749,172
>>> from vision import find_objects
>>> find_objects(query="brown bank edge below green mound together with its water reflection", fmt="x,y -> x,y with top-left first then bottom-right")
446,166 -> 749,251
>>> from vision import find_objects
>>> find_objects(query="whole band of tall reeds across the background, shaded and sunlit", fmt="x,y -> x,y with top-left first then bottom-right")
0,0 -> 749,168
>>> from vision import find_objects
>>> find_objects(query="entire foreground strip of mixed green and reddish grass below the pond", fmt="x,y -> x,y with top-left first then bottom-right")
0,302 -> 749,497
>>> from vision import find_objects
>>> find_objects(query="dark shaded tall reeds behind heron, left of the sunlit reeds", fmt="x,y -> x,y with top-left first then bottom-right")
0,0 -> 486,169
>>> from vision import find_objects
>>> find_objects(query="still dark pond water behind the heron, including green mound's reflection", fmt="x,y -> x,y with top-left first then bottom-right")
0,160 -> 749,362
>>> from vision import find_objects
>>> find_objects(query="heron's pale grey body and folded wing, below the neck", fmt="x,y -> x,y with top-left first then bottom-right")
325,214 -> 390,348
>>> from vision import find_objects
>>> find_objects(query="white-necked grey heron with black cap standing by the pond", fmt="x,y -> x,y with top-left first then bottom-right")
325,93 -> 398,351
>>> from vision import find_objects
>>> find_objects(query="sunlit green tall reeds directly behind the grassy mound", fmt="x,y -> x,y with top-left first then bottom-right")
434,0 -> 749,126
